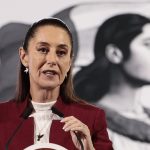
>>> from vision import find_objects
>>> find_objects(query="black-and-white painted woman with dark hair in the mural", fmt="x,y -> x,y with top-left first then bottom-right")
74,14 -> 150,150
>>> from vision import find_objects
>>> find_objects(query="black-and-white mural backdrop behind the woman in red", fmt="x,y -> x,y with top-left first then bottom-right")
0,0 -> 150,150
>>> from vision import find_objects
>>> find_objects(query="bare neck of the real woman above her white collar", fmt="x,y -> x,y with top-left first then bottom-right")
30,87 -> 60,103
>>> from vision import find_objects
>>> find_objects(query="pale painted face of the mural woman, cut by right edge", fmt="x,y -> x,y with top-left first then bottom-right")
123,24 -> 150,82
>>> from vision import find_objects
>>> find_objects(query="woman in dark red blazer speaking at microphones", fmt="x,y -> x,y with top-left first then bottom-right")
0,18 -> 112,150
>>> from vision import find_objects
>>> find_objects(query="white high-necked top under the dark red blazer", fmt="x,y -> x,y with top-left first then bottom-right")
30,101 -> 61,144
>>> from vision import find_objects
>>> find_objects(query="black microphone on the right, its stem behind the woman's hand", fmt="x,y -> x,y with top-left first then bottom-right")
51,106 -> 84,150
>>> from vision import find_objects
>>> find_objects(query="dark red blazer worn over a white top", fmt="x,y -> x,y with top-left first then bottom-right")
0,98 -> 113,150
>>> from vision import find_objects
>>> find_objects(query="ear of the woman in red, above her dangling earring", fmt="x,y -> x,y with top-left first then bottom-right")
19,47 -> 28,67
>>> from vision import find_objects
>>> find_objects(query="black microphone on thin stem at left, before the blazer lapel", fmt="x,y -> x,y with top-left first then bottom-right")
6,103 -> 33,150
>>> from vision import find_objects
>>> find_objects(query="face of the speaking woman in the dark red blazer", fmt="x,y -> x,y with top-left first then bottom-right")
22,25 -> 72,89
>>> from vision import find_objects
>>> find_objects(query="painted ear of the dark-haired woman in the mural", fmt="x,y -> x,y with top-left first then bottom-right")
105,44 -> 123,64
